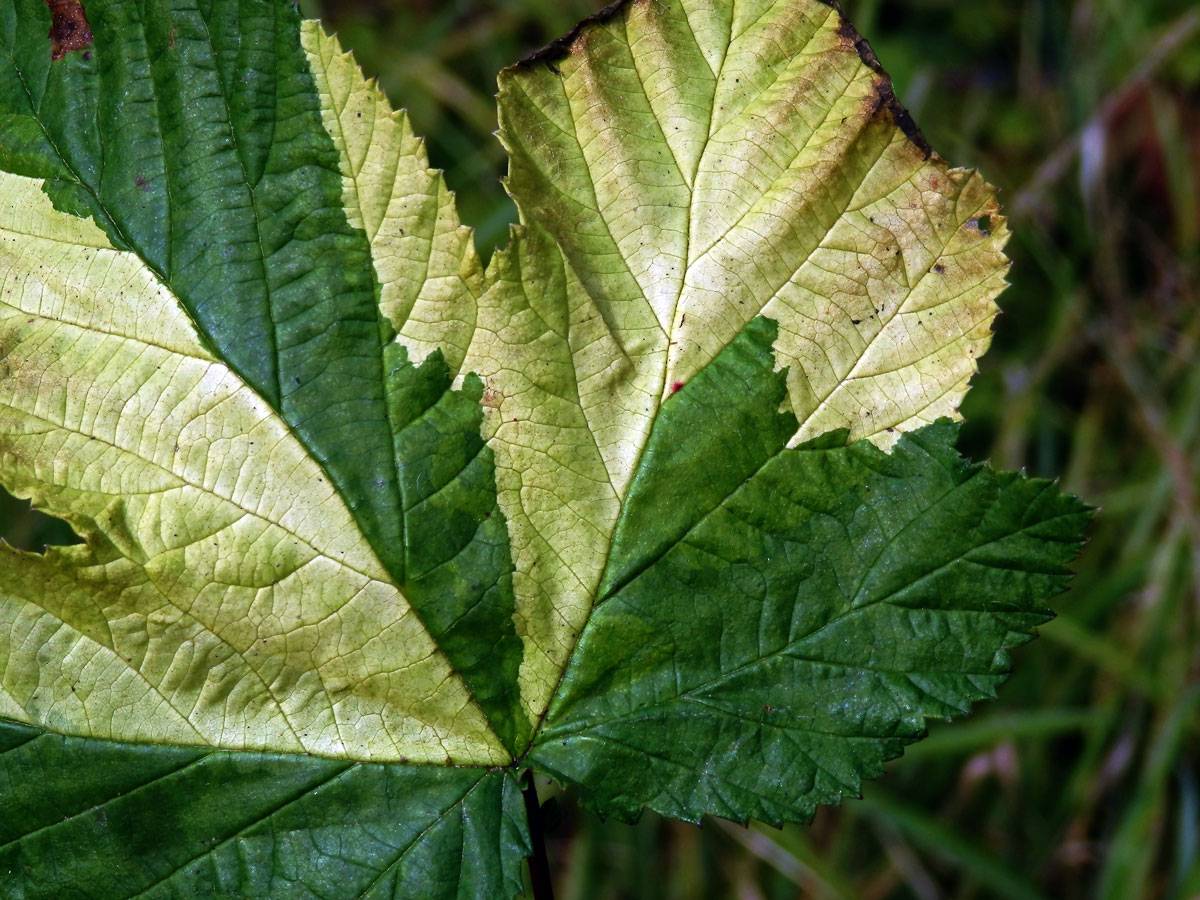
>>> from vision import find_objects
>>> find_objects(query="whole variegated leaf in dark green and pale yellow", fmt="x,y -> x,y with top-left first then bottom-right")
0,0 -> 1088,898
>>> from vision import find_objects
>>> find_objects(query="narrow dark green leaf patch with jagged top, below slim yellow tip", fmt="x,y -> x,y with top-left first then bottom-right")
385,343 -> 532,754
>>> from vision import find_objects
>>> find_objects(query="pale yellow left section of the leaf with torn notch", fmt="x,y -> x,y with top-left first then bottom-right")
0,174 -> 508,764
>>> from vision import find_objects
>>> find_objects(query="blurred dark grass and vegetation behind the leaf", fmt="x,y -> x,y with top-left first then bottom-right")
6,0 -> 1200,900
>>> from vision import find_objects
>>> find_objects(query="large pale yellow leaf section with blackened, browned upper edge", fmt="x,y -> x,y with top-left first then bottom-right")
464,0 -> 1008,710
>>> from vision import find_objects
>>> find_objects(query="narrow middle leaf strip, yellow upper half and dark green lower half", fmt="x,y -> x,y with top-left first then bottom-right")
300,22 -> 532,754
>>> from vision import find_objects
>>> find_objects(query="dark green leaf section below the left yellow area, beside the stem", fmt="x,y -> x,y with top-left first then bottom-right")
0,721 -> 529,900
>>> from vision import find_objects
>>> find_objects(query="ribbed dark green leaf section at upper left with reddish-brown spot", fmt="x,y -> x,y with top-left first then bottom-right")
0,0 -> 403,577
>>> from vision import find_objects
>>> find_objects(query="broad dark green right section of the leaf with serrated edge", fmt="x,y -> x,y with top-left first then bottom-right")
529,319 -> 1090,822
